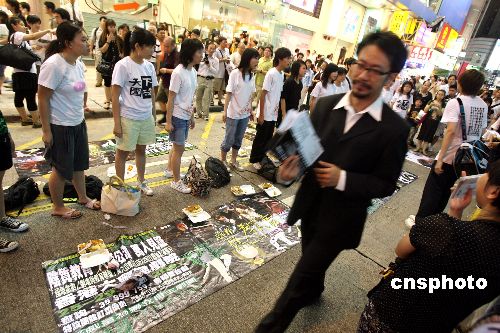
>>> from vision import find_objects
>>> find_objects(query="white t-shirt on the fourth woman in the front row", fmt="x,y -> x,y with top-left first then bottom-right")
226,69 -> 256,119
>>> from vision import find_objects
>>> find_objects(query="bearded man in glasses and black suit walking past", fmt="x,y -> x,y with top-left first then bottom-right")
256,32 -> 409,333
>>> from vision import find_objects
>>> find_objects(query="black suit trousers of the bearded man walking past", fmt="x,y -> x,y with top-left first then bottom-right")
256,219 -> 344,333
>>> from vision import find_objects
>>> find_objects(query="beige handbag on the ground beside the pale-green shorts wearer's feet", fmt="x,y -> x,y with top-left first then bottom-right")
101,176 -> 141,216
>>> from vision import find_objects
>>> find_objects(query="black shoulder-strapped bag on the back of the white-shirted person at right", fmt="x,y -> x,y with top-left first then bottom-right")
453,98 -> 490,177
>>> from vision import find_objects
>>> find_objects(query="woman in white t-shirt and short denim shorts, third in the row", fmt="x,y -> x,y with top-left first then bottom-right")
165,39 -> 203,193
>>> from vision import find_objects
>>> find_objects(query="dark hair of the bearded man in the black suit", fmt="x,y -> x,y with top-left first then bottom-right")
356,31 -> 408,73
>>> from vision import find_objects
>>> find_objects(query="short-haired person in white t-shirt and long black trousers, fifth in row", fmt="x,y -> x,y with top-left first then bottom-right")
250,47 -> 292,170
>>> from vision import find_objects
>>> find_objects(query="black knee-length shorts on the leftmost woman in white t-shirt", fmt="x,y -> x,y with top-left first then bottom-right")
45,120 -> 89,180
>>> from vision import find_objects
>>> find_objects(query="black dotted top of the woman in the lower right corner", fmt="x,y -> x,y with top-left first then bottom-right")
369,213 -> 500,333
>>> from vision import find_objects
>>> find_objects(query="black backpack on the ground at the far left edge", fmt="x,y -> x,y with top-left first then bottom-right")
3,177 -> 40,216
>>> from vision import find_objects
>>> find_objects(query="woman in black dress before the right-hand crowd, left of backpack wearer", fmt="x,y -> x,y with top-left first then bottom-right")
415,90 -> 446,155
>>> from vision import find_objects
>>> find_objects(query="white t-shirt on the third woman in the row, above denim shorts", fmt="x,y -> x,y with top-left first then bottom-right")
169,64 -> 197,120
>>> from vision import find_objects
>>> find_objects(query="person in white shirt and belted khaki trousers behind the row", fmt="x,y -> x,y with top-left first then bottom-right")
194,42 -> 219,120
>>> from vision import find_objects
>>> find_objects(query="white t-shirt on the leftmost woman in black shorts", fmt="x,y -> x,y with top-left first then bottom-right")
38,53 -> 86,126
